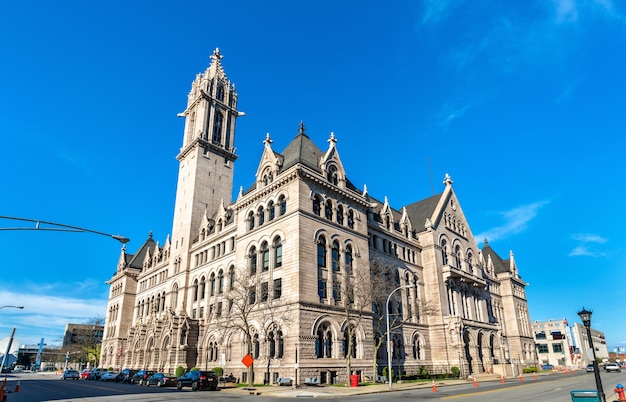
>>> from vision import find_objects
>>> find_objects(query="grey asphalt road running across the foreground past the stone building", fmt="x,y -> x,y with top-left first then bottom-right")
1,371 -> 626,402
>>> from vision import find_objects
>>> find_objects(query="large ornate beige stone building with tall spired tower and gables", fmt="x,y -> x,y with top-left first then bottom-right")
101,50 -> 536,383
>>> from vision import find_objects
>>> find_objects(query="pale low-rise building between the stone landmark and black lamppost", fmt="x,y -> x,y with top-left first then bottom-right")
532,318 -> 580,367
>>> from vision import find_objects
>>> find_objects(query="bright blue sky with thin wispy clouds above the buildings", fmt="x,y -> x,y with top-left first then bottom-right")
0,0 -> 626,349
